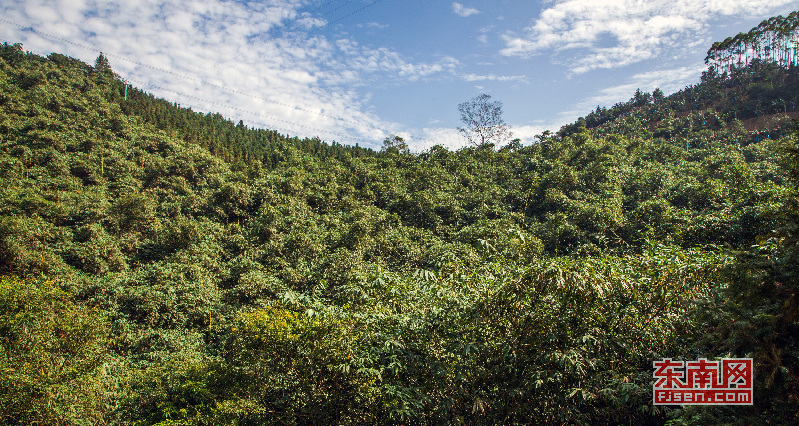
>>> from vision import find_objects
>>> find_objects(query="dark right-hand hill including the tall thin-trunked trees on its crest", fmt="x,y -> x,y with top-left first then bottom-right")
558,12 -> 799,143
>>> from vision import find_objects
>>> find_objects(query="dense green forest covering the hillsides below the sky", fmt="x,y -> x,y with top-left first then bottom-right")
0,12 -> 799,425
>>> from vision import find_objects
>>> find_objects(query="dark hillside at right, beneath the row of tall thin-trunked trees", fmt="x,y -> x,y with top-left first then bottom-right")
558,61 -> 799,143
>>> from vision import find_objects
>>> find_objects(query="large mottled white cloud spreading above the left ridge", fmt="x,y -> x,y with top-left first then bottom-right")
0,0 -> 459,147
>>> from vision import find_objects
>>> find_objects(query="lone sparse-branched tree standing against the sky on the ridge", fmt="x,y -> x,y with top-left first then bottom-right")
458,94 -> 513,147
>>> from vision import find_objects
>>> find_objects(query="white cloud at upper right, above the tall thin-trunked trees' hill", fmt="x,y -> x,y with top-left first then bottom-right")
500,0 -> 794,74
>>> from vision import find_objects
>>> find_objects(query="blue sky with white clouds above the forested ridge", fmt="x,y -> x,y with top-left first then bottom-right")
0,0 -> 799,151
